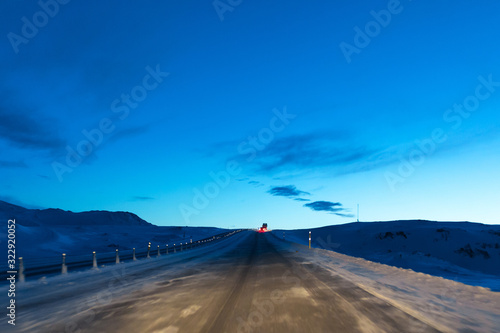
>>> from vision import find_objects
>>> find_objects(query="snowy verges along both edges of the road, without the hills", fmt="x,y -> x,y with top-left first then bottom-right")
0,232 -> 500,332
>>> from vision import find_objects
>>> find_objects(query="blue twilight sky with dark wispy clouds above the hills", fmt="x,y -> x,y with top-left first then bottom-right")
0,0 -> 500,228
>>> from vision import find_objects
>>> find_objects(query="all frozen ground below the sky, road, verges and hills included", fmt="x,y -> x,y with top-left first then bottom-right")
0,202 -> 500,333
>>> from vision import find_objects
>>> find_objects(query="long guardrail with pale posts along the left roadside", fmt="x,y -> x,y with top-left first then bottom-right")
0,230 -> 242,282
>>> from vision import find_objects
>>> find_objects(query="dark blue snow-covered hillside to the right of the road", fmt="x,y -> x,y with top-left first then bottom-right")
273,220 -> 500,291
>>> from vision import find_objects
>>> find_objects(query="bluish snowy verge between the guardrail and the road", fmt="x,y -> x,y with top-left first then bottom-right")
0,233 -> 248,332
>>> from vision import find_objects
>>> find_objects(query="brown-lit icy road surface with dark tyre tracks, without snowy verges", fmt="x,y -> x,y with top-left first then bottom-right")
14,231 -> 438,333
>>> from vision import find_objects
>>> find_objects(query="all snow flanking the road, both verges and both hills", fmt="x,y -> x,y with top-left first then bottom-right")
0,202 -> 500,332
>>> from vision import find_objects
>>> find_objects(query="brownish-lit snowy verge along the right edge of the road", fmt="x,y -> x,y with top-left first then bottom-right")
270,237 -> 500,332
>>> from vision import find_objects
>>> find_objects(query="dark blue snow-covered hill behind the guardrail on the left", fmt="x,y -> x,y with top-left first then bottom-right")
0,201 -> 225,260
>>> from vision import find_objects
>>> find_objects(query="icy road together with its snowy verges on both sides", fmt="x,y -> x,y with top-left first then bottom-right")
0,231 -> 500,333
